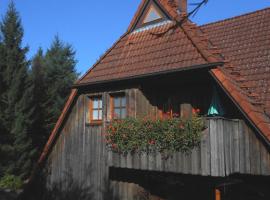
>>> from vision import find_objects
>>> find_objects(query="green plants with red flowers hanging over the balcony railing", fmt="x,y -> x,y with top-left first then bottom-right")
105,115 -> 205,154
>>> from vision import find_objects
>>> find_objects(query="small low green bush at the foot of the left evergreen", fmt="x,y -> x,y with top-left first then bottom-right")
0,175 -> 23,190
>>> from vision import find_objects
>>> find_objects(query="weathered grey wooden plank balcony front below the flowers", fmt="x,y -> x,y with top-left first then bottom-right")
109,118 -> 270,177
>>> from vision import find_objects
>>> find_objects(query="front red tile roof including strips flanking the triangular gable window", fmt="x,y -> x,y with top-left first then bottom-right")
77,0 -> 222,85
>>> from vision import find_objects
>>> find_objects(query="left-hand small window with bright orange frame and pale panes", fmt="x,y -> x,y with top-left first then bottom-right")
90,96 -> 103,122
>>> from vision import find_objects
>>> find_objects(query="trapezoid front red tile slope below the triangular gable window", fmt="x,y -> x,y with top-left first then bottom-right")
77,23 -> 212,84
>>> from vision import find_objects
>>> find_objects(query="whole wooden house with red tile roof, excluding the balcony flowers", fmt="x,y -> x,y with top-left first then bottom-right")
26,0 -> 270,200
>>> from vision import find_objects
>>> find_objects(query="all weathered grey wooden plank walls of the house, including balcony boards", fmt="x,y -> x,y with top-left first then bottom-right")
47,89 -> 270,200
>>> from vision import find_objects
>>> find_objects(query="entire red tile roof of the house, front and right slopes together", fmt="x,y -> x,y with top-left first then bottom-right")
76,0 -> 270,140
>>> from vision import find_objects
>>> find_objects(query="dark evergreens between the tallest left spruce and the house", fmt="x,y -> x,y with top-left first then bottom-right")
30,36 -> 78,155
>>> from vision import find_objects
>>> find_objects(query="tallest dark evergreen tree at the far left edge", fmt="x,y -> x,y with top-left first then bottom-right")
0,3 -> 34,178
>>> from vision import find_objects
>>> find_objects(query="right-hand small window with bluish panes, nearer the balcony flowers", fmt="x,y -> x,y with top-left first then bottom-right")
111,93 -> 127,119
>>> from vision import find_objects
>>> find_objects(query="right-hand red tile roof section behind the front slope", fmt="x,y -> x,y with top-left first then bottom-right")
201,8 -> 270,141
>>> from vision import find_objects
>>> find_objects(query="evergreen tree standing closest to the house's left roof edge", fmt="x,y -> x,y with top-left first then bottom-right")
42,36 -> 78,132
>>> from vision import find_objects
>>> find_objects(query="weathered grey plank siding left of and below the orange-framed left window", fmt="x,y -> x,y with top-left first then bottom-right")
48,96 -> 108,200
